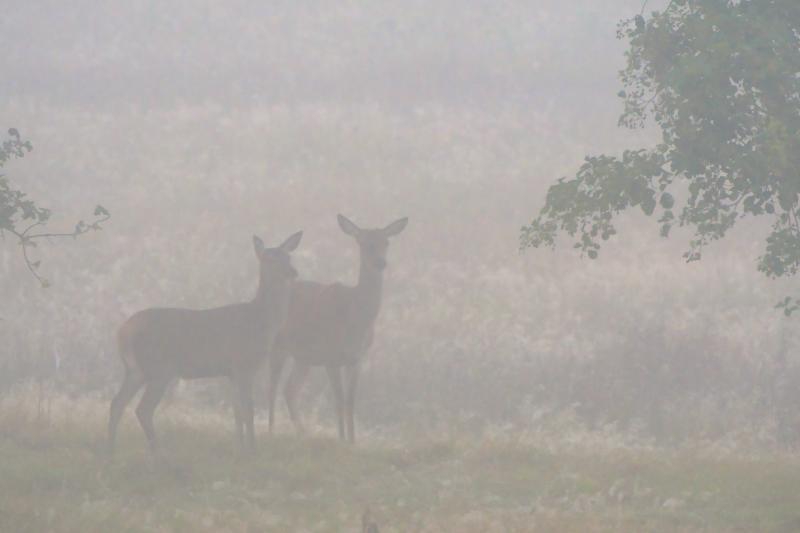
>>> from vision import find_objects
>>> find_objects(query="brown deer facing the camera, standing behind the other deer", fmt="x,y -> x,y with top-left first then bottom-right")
269,215 -> 408,442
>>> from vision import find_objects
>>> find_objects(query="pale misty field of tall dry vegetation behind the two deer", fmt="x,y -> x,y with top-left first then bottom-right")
0,0 -> 800,445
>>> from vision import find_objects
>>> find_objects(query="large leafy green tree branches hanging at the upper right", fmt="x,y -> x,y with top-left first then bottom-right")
520,0 -> 800,314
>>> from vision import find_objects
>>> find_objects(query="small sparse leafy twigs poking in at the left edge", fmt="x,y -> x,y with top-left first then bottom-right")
0,128 -> 110,287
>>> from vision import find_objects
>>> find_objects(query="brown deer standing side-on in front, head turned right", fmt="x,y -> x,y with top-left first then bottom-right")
108,232 -> 303,455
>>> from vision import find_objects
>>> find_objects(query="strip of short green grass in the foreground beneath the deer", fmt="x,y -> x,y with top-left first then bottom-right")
0,390 -> 800,532
